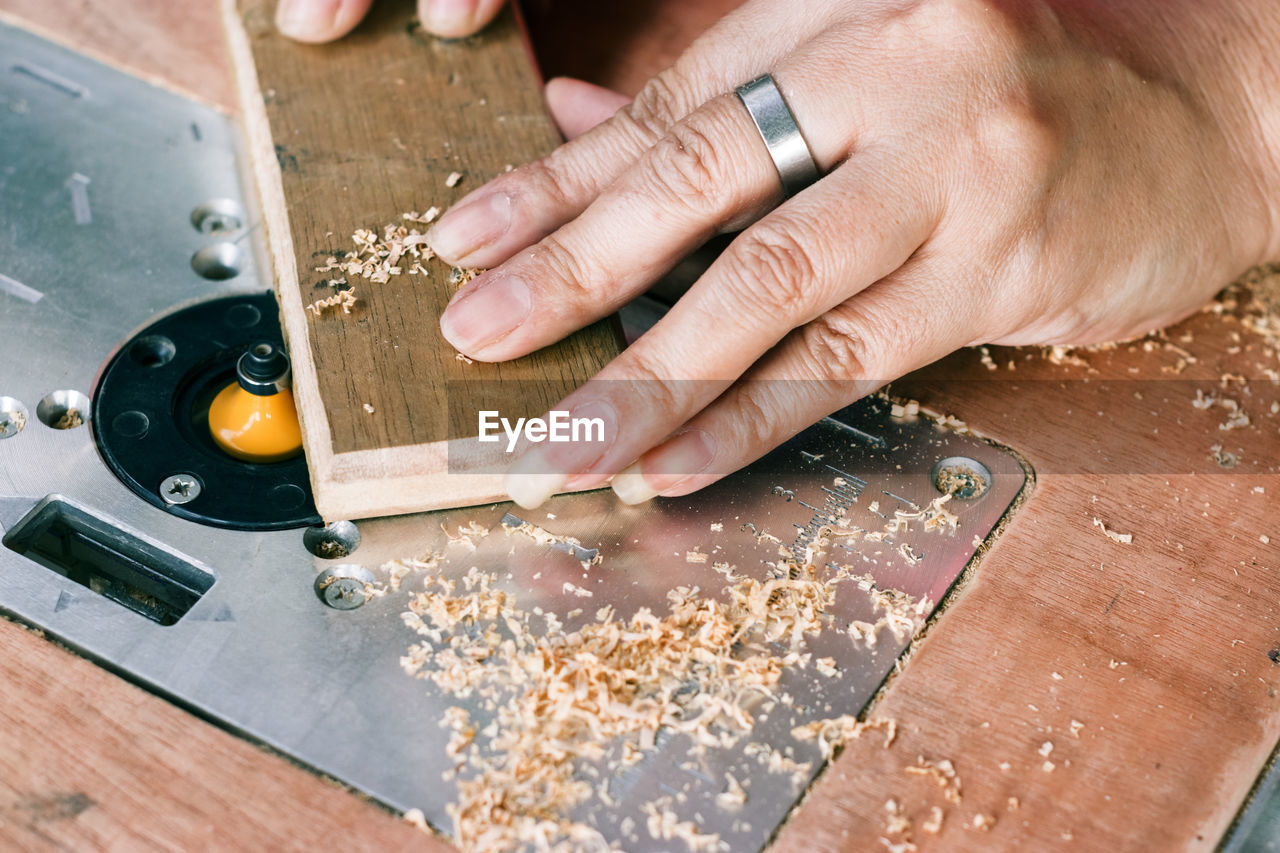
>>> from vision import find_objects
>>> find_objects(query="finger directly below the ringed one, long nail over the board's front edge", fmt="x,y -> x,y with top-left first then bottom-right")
494,155 -> 936,506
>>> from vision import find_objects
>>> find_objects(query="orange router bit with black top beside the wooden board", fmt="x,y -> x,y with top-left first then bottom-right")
209,343 -> 302,462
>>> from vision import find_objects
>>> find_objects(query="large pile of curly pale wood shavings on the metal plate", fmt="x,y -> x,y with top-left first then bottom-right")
393,545 -> 928,852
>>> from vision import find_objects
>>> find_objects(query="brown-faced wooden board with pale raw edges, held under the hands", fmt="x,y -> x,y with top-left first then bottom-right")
225,0 -> 618,520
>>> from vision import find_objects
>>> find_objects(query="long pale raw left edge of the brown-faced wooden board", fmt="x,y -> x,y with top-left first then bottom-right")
220,0 -> 337,507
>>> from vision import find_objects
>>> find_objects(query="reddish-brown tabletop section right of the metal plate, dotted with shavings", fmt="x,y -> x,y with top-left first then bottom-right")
774,282 -> 1280,853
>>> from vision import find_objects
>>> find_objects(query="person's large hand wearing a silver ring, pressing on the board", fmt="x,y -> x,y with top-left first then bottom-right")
429,0 -> 1280,507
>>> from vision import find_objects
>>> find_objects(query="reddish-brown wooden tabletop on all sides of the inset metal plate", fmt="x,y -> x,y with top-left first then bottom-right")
0,0 -> 1280,850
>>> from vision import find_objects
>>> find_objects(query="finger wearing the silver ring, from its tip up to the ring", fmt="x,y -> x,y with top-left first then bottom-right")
440,95 -> 778,361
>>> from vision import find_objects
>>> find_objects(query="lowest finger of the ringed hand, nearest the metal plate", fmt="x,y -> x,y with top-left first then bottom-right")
612,262 -> 975,503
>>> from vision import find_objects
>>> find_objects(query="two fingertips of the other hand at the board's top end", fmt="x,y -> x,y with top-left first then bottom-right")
275,0 -> 504,42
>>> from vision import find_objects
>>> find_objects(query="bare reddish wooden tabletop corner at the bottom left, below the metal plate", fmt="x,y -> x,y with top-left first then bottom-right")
0,619 -> 453,853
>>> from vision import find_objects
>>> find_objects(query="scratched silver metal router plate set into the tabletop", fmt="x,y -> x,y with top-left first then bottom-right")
0,21 -> 1024,850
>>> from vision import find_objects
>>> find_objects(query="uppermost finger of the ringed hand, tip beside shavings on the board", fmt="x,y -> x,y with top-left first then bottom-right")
428,0 -> 838,268
